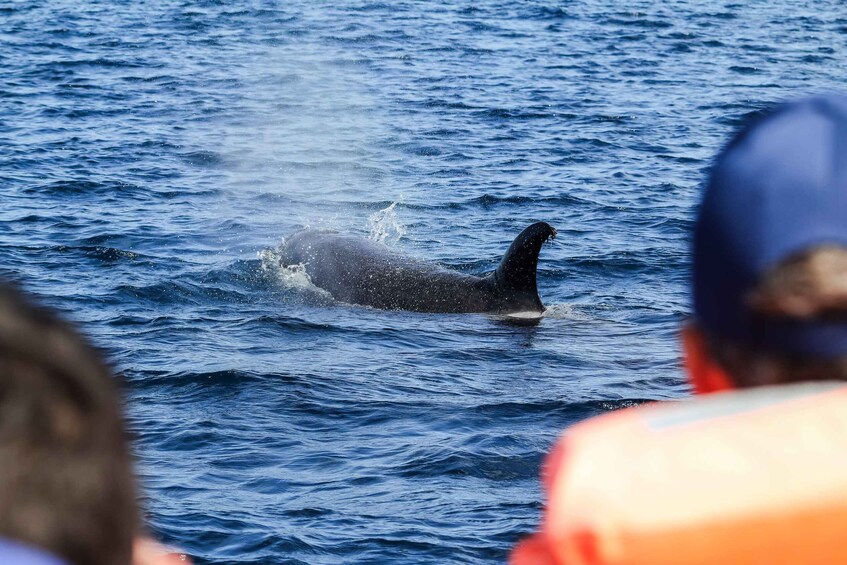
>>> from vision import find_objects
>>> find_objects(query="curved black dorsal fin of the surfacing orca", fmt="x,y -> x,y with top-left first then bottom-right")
494,222 -> 556,311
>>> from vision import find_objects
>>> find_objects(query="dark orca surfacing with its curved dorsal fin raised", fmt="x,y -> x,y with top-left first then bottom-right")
280,222 -> 556,315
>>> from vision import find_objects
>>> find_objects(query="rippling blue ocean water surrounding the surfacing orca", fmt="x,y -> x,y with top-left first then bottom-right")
0,0 -> 847,564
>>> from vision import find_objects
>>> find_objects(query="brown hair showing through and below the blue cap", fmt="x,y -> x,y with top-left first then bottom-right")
709,245 -> 847,387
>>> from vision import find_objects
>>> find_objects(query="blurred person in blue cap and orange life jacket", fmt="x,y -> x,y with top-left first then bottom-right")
511,96 -> 847,565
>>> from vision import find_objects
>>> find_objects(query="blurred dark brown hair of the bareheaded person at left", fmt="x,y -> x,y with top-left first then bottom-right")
0,284 -> 139,565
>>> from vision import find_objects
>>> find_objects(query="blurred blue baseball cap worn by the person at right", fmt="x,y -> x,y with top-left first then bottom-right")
694,96 -> 847,357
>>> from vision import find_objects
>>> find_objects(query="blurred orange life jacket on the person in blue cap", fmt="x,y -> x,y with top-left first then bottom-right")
510,383 -> 847,565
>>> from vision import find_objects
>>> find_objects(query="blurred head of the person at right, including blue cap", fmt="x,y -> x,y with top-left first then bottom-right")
683,96 -> 847,392
